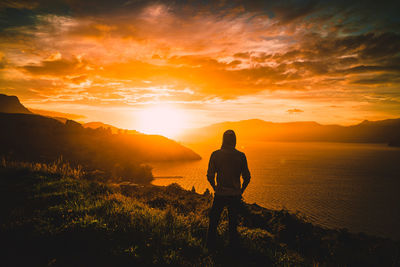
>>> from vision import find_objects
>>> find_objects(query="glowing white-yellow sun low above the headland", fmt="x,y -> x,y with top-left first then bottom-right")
137,105 -> 186,138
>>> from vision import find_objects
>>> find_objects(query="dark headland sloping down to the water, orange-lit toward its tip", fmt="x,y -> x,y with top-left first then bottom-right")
0,113 -> 200,183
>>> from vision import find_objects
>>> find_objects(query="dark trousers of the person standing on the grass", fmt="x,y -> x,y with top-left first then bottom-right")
207,195 -> 242,249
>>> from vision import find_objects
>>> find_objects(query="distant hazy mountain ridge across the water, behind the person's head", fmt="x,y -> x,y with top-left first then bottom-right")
179,119 -> 400,146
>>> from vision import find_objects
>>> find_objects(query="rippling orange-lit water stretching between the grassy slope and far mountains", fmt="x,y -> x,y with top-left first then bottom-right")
151,142 -> 400,240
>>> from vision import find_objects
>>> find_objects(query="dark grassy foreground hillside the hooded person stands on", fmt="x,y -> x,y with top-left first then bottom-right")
0,161 -> 400,266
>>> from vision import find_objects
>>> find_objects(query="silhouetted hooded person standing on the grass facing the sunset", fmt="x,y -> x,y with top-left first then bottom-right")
207,130 -> 250,249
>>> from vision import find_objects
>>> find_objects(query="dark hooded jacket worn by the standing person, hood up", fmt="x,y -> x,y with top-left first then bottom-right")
207,130 -> 250,196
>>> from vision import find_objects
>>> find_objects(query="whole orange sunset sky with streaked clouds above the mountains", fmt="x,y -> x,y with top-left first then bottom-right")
0,0 -> 400,136
